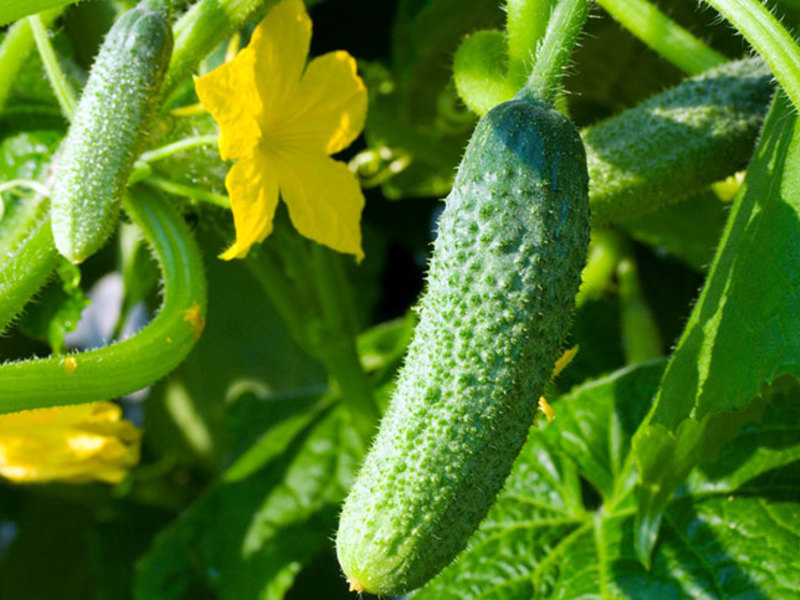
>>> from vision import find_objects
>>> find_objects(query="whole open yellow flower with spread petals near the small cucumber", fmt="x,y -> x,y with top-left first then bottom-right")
195,0 -> 367,260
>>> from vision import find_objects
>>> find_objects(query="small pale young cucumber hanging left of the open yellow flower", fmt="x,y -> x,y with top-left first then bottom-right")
51,6 -> 172,263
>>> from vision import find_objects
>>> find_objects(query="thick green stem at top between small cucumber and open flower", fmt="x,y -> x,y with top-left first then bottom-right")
162,0 -> 277,99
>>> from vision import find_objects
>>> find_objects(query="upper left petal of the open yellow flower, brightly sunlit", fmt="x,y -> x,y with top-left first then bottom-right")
194,48 -> 263,160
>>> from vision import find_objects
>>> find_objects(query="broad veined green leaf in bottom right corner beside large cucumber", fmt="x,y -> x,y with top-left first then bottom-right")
413,362 -> 800,600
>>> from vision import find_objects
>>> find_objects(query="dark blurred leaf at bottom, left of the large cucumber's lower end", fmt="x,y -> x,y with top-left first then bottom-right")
135,398 -> 359,600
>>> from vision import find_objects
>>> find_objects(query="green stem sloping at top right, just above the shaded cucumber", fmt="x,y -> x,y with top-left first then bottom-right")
598,0 -> 728,75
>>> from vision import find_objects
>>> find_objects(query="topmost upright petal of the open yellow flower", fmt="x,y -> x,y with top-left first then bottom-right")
247,0 -> 311,124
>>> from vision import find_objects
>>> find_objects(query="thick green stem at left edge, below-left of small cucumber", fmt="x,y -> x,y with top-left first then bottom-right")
0,197 -> 59,332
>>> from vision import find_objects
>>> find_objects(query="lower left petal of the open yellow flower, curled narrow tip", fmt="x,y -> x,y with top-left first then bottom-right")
220,151 -> 278,260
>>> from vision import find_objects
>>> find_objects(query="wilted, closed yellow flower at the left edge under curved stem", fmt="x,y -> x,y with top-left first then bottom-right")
0,402 -> 141,483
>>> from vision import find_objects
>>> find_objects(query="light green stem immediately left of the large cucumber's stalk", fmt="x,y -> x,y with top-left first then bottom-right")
506,0 -> 552,87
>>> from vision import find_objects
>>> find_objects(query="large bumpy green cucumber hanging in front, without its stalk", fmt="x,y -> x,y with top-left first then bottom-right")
337,100 -> 589,595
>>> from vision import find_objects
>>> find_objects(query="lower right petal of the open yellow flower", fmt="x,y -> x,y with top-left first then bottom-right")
276,148 -> 364,260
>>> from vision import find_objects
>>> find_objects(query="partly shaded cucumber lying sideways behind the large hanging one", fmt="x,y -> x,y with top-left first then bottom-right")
583,58 -> 774,225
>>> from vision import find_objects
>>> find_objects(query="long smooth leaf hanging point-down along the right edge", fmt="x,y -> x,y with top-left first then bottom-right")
634,95 -> 800,563
